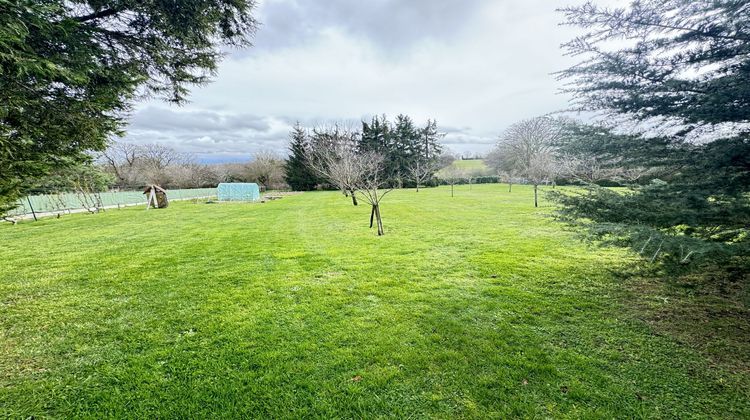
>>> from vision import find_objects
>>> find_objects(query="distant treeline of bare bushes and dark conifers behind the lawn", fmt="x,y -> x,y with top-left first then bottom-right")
29,115 -> 453,198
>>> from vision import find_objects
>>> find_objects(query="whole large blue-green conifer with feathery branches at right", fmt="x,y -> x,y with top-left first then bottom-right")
555,0 -> 750,268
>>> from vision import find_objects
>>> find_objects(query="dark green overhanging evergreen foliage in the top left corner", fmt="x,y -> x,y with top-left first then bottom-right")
0,0 -> 255,214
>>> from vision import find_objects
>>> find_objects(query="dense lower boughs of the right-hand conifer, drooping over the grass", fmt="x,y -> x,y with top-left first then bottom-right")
553,128 -> 750,267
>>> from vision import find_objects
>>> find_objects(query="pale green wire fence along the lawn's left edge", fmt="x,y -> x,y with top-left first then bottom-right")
8,188 -> 217,216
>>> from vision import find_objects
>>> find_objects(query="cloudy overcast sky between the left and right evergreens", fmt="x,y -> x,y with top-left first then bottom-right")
124,0 -> 592,162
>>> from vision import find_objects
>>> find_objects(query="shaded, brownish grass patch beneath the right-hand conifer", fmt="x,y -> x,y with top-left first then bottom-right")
620,259 -> 750,375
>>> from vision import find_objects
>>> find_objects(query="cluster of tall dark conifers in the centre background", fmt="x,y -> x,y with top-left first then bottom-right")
284,114 -> 453,191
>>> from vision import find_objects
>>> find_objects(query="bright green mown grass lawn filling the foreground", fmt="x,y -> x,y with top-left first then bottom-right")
0,185 -> 750,418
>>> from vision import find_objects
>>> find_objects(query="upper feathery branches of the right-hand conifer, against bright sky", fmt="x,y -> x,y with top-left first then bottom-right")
560,0 -> 750,130
